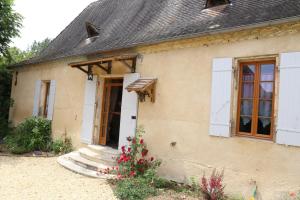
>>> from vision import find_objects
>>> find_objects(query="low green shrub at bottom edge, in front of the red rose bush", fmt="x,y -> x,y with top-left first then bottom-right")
114,176 -> 157,200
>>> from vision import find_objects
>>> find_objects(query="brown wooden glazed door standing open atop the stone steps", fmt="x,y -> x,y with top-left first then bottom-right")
99,78 -> 123,145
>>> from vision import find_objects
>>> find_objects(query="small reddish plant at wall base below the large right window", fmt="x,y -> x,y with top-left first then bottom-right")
200,169 -> 226,200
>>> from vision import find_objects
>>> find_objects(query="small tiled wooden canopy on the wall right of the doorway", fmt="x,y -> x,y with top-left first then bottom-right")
126,78 -> 157,102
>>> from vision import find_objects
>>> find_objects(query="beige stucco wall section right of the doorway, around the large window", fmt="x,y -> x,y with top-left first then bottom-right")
138,21 -> 300,199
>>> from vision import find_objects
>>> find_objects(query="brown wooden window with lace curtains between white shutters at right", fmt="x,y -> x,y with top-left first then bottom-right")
237,61 -> 275,139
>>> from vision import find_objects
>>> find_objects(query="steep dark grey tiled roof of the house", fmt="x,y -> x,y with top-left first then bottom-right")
14,0 -> 300,65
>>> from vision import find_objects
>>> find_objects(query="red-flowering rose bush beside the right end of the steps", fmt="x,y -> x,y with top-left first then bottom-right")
101,129 -> 161,179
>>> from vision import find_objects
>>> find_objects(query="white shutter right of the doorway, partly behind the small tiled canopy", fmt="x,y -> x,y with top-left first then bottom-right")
119,73 -> 140,148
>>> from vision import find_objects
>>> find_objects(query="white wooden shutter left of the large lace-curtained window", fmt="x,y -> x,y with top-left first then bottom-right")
209,58 -> 232,137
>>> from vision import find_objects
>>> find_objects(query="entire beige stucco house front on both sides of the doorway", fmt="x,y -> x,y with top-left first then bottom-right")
12,23 -> 300,199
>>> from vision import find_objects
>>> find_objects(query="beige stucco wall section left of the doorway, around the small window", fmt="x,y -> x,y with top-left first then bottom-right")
10,58 -> 85,146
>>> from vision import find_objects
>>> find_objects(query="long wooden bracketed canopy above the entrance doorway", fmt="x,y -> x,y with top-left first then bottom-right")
69,54 -> 138,80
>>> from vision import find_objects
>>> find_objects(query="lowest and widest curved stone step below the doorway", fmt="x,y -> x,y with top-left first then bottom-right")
57,154 -> 115,179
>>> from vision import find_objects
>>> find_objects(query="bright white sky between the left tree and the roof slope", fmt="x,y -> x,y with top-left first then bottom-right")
12,0 -> 95,50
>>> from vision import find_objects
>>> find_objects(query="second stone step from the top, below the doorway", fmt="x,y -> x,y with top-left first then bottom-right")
78,148 -> 116,167
